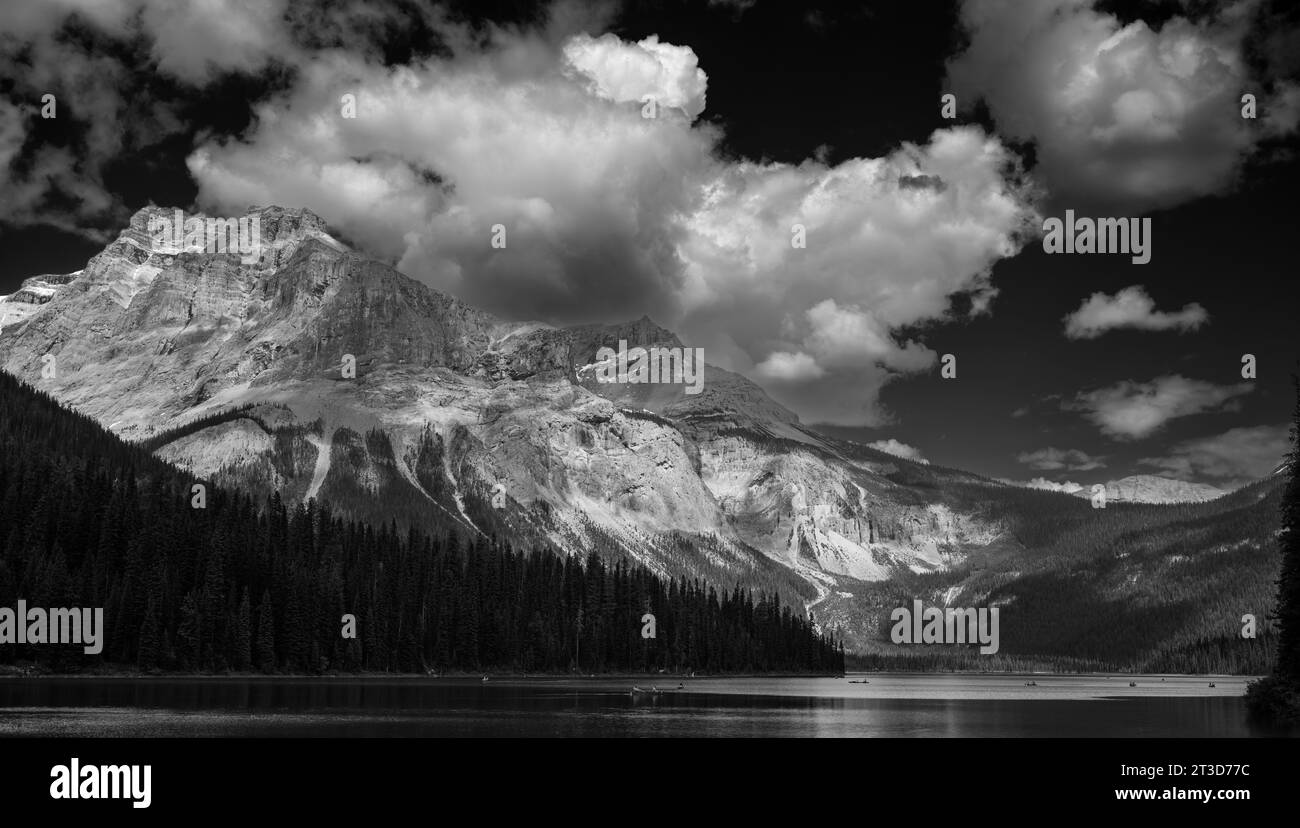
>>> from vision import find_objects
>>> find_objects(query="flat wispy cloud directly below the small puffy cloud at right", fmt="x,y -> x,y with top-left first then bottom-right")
1062,374 -> 1255,439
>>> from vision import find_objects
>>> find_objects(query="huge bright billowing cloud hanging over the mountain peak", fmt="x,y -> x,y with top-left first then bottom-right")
190,25 -> 1037,424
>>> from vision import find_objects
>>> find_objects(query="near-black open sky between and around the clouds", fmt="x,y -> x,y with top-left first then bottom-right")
0,0 -> 1300,485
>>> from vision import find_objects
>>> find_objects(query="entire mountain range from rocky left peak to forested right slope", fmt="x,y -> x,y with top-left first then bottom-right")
0,207 -> 1279,664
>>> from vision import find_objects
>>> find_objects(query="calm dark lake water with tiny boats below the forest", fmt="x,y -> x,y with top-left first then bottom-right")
0,673 -> 1277,738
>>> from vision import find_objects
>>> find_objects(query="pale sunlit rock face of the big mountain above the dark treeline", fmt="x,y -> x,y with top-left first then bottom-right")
0,201 -> 1002,639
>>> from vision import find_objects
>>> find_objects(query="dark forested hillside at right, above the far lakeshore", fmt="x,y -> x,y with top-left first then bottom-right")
837,478 -> 1283,675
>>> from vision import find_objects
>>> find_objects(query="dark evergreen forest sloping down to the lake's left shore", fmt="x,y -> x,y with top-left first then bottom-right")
0,373 -> 844,672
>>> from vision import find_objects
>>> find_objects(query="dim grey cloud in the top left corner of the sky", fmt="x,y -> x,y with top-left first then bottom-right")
0,0 -> 293,240
